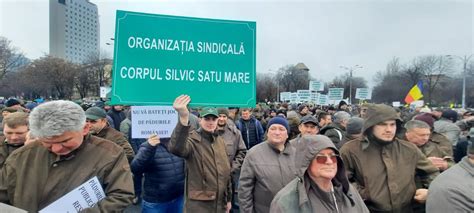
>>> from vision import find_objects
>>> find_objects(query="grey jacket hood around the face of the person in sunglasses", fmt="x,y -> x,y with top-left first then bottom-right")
295,135 -> 349,193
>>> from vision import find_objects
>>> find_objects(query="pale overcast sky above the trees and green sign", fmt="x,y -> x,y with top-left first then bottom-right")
0,0 -> 474,86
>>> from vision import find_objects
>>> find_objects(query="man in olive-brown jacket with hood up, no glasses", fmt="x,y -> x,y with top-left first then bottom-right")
341,104 -> 439,213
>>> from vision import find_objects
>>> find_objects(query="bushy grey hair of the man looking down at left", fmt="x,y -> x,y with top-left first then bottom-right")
29,100 -> 86,138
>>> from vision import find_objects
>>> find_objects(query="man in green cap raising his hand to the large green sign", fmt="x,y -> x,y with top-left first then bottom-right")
169,95 -> 231,212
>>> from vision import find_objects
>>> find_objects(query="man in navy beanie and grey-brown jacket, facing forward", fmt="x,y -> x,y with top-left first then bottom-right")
239,116 -> 296,213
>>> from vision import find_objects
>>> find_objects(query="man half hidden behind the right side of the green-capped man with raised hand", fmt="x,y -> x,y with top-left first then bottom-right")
217,108 -> 247,209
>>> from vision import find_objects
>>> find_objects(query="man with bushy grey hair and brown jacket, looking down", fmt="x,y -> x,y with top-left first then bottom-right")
0,100 -> 134,212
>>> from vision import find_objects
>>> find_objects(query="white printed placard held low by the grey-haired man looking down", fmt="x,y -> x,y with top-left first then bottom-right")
39,176 -> 105,213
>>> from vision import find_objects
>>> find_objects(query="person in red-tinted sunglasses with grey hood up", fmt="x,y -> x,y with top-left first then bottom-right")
270,135 -> 369,213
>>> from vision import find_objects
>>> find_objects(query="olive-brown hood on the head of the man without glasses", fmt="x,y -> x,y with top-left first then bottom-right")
362,104 -> 402,135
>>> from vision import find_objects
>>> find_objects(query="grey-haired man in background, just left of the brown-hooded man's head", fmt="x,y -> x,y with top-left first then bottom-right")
320,111 -> 351,148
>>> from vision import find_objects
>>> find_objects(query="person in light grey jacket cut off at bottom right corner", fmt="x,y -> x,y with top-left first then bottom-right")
426,138 -> 474,212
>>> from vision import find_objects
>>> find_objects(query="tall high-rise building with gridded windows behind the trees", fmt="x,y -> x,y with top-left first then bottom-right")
49,0 -> 100,63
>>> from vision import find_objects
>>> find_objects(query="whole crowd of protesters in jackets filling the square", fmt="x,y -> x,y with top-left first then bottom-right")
0,95 -> 474,213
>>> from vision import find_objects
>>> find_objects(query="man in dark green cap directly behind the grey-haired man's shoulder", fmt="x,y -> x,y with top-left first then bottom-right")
86,107 -> 134,163
